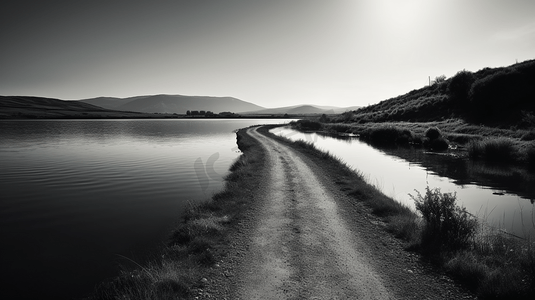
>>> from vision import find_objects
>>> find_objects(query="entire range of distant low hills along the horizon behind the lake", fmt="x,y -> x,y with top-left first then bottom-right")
0,95 -> 362,118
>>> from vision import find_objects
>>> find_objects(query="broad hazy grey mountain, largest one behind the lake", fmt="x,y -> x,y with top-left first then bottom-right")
80,95 -> 263,114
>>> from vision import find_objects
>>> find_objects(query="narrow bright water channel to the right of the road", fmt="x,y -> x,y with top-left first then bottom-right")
272,128 -> 535,238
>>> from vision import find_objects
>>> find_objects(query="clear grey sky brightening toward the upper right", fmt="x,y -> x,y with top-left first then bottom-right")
0,0 -> 535,107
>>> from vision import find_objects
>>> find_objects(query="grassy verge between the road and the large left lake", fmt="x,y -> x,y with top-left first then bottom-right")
87,126 -> 265,300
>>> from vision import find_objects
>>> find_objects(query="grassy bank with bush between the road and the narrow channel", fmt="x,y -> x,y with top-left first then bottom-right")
260,129 -> 535,299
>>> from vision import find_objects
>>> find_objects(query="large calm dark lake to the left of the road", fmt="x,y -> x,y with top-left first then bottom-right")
0,119 -> 292,299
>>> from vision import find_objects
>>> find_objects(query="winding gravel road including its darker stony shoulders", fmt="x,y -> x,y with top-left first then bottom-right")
205,128 -> 471,299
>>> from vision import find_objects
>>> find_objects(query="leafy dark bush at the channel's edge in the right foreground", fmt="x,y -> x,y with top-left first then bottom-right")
410,187 -> 477,252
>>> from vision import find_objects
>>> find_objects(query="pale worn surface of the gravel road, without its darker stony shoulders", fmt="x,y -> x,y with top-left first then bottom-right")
235,128 -> 394,299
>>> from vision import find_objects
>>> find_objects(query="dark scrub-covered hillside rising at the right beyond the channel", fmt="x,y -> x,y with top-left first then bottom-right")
338,60 -> 535,128
